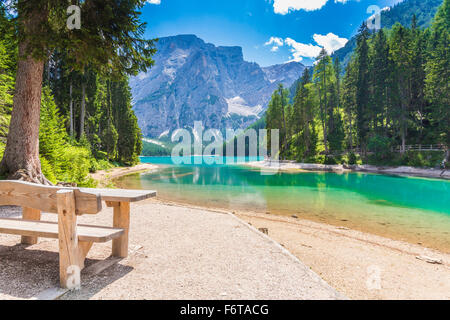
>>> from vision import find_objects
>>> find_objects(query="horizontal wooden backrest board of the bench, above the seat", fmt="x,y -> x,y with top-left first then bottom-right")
0,180 -> 102,215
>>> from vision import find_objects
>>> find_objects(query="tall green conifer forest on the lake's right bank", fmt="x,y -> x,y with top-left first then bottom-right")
267,0 -> 450,166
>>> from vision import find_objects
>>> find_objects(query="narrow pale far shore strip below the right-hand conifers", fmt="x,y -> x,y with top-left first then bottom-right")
246,160 -> 450,179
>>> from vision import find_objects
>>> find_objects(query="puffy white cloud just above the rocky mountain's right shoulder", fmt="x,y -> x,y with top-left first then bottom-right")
265,32 -> 348,62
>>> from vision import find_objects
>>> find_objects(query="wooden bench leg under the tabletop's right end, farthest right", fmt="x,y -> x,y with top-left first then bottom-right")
110,202 -> 130,258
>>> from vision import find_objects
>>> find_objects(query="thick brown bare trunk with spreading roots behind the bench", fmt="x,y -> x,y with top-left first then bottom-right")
0,42 -> 50,184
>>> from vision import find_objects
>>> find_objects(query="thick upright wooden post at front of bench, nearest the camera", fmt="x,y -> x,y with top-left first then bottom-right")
56,190 -> 84,289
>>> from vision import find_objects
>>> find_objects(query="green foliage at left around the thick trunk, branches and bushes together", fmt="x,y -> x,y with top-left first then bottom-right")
0,0 -> 156,186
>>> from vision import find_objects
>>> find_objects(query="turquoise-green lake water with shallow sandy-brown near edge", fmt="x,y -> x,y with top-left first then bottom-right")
117,157 -> 450,252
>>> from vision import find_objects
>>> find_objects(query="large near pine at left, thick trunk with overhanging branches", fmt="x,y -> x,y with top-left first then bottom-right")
0,0 -> 154,183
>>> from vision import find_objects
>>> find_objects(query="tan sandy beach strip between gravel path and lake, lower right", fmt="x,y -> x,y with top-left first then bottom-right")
236,212 -> 450,299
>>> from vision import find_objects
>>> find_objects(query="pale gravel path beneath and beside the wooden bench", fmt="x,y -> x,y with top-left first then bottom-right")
0,200 -> 345,299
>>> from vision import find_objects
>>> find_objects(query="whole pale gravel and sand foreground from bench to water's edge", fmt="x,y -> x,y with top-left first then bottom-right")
0,199 -> 450,299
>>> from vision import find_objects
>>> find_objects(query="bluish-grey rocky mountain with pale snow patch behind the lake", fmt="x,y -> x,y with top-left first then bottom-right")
130,35 -> 305,137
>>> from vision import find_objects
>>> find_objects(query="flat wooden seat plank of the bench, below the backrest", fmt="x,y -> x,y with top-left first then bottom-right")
0,218 -> 124,242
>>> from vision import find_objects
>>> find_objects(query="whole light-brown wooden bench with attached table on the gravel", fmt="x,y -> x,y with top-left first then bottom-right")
0,181 -> 156,289
